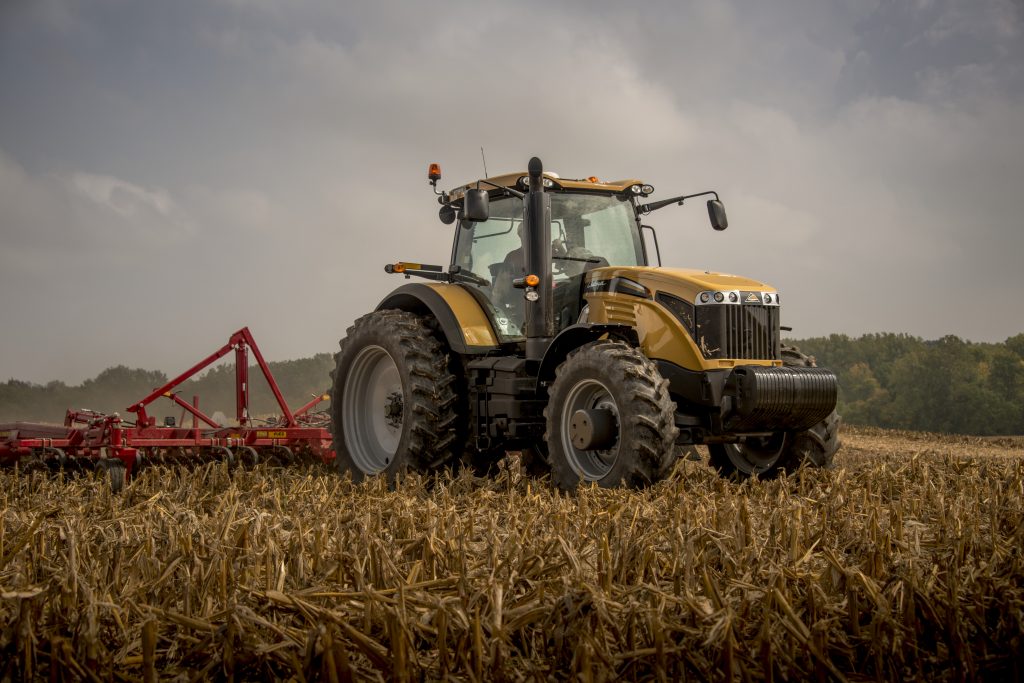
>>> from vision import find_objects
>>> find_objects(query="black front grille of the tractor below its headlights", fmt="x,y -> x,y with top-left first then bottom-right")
696,304 -> 779,360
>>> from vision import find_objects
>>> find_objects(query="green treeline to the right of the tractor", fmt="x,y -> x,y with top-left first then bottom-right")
791,334 -> 1024,435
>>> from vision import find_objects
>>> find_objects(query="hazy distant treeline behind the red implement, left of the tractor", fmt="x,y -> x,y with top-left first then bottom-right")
0,353 -> 334,425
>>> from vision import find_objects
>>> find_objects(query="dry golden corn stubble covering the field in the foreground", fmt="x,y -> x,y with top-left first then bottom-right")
0,429 -> 1024,682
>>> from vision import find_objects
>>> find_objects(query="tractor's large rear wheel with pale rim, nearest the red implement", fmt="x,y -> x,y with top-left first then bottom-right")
331,310 -> 458,481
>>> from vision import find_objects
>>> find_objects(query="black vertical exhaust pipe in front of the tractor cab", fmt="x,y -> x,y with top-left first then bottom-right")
523,157 -> 555,360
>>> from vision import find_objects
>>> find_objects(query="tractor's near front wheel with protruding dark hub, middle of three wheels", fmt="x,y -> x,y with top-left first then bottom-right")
544,341 -> 678,489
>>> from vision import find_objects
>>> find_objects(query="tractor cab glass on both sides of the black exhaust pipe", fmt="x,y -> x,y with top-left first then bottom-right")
454,193 -> 644,341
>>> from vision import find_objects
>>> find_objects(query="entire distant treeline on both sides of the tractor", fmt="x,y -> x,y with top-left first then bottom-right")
0,334 -> 1024,435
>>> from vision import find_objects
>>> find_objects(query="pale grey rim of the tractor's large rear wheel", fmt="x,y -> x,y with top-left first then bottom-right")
342,346 -> 406,474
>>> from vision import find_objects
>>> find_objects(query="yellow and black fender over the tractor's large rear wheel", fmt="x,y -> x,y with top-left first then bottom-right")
377,283 -> 500,355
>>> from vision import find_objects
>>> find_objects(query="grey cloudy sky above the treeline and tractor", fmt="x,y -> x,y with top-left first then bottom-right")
0,0 -> 1024,382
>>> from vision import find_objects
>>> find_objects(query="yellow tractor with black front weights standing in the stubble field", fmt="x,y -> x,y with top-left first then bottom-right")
331,158 -> 840,488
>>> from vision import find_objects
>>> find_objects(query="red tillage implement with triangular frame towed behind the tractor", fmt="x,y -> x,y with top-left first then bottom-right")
0,328 -> 335,490
